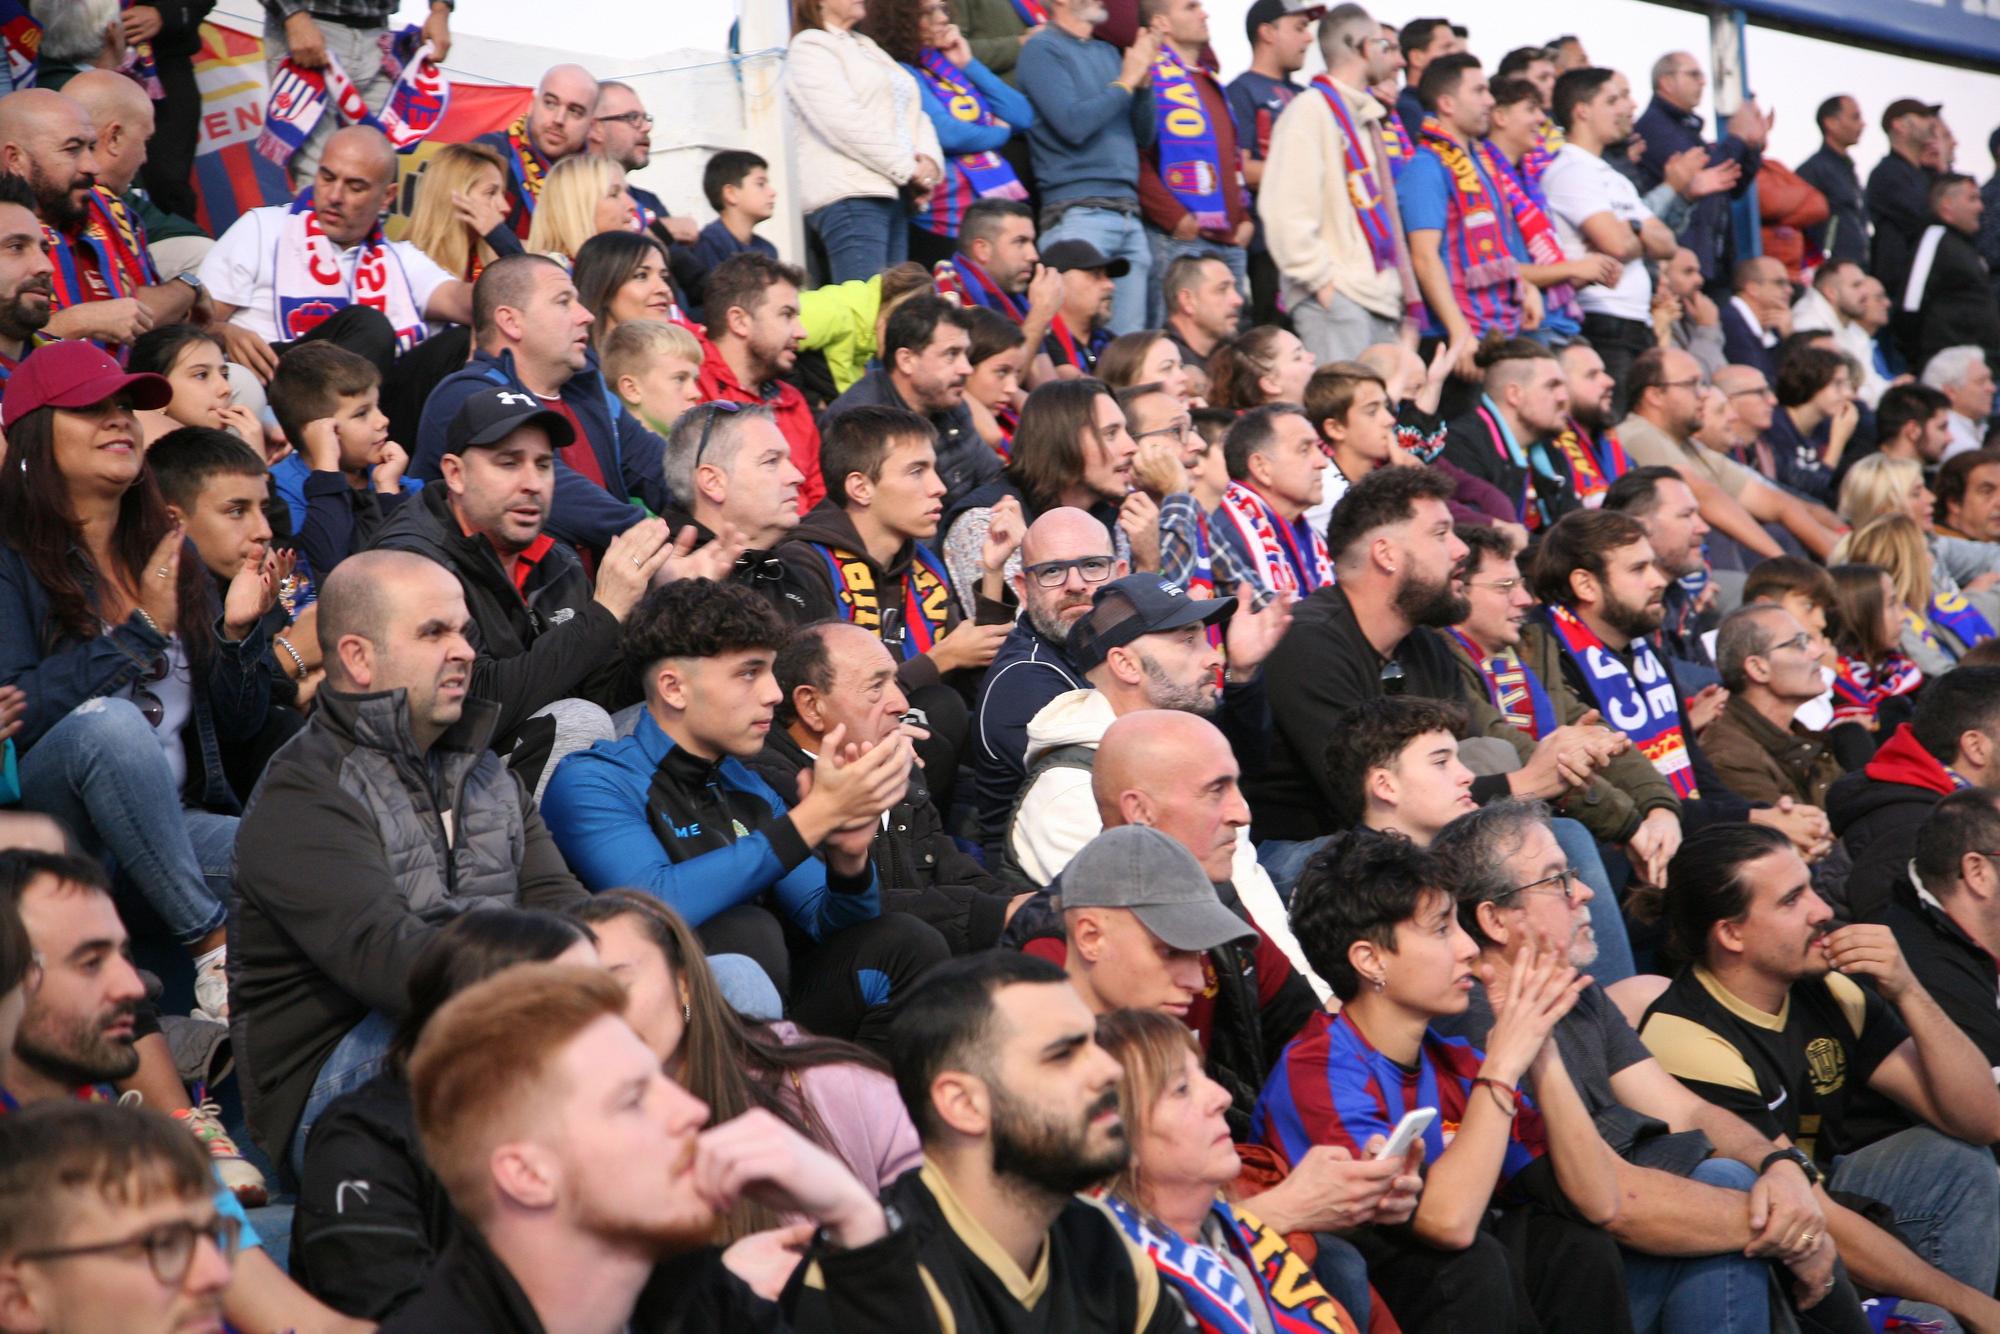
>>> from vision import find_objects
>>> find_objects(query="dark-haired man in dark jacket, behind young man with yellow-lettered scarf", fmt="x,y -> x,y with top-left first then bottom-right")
820,296 -> 1000,504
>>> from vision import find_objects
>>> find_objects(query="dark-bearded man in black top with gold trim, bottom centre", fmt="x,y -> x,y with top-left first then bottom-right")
884,950 -> 1188,1334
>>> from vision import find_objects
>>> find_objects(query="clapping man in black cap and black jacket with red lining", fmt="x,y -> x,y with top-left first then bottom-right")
374,388 -> 676,792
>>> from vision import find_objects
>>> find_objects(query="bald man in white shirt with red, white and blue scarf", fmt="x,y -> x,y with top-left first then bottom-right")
200,126 -> 472,380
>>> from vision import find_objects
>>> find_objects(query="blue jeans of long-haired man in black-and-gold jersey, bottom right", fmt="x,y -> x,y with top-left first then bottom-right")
1826,1126 -> 2000,1328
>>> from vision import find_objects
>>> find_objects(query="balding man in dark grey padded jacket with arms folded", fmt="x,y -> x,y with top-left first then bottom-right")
230,550 -> 584,1178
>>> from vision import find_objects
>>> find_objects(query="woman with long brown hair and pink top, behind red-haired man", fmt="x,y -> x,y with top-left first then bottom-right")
572,890 -> 922,1244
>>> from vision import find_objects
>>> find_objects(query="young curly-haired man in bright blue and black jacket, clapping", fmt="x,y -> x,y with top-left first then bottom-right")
542,580 -> 950,1038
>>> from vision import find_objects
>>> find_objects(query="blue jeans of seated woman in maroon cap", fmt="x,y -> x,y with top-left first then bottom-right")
20,696 -> 236,944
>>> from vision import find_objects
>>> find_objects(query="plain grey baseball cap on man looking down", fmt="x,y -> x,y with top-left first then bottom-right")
1062,824 -> 1256,950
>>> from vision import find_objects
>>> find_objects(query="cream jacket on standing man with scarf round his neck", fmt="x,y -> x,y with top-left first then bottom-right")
1256,75 -> 1414,320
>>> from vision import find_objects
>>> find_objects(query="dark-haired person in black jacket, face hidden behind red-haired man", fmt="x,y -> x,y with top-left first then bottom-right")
292,908 -> 598,1320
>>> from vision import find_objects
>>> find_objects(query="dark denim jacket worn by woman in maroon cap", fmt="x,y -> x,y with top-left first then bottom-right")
0,546 -> 270,814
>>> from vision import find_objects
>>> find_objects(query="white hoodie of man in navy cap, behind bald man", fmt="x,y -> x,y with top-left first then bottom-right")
1008,690 -> 1334,1002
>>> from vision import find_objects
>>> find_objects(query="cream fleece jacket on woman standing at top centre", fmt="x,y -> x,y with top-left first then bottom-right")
784,28 -> 944,214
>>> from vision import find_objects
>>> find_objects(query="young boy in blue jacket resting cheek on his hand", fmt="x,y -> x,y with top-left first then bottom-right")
268,342 -> 418,578
